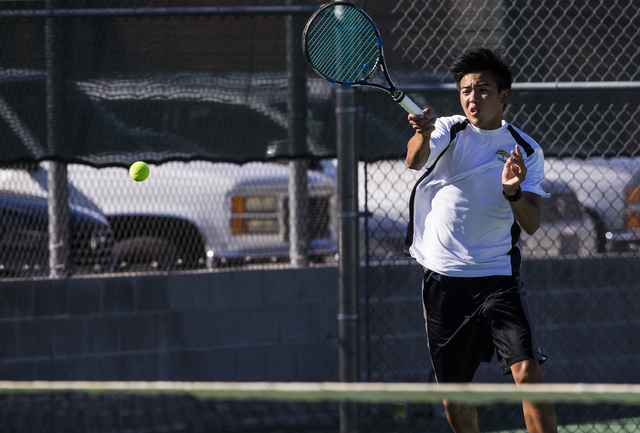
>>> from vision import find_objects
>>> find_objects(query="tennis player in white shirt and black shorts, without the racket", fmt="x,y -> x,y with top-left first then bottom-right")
407,48 -> 557,433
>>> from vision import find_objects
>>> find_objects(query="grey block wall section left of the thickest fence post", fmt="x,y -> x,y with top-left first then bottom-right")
0,267 -> 338,381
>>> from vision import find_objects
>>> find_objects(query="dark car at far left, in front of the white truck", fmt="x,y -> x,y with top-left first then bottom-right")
0,192 -> 115,278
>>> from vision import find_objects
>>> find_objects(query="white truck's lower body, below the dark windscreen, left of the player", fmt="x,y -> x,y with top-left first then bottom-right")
0,161 -> 337,271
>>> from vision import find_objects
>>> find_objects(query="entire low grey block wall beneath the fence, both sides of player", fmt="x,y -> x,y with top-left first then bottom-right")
0,258 -> 640,382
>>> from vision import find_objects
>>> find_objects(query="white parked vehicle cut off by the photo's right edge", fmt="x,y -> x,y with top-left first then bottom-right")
545,157 -> 640,253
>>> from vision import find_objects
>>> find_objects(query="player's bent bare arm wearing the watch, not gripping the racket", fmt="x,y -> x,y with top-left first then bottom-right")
502,145 -> 541,235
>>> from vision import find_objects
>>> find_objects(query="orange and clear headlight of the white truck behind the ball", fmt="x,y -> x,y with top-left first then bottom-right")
230,195 -> 280,235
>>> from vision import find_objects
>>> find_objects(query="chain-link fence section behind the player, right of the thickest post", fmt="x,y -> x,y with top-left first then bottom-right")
361,0 -> 640,423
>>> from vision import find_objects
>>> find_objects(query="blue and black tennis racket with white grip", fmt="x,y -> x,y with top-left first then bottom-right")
302,1 -> 423,115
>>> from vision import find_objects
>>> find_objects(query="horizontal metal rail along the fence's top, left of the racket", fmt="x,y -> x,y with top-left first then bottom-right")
0,5 -> 319,19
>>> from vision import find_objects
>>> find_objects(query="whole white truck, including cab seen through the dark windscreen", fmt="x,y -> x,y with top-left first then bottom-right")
0,70 -> 344,271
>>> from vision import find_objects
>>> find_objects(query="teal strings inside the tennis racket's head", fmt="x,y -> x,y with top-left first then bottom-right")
307,8 -> 380,83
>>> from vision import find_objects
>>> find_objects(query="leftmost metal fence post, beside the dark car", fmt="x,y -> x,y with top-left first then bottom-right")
44,0 -> 69,278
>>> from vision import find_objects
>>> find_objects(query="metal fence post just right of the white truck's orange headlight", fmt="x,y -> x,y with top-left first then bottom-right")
287,0 -> 309,268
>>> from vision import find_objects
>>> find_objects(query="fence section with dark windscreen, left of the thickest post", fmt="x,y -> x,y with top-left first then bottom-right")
0,1 -> 338,277
